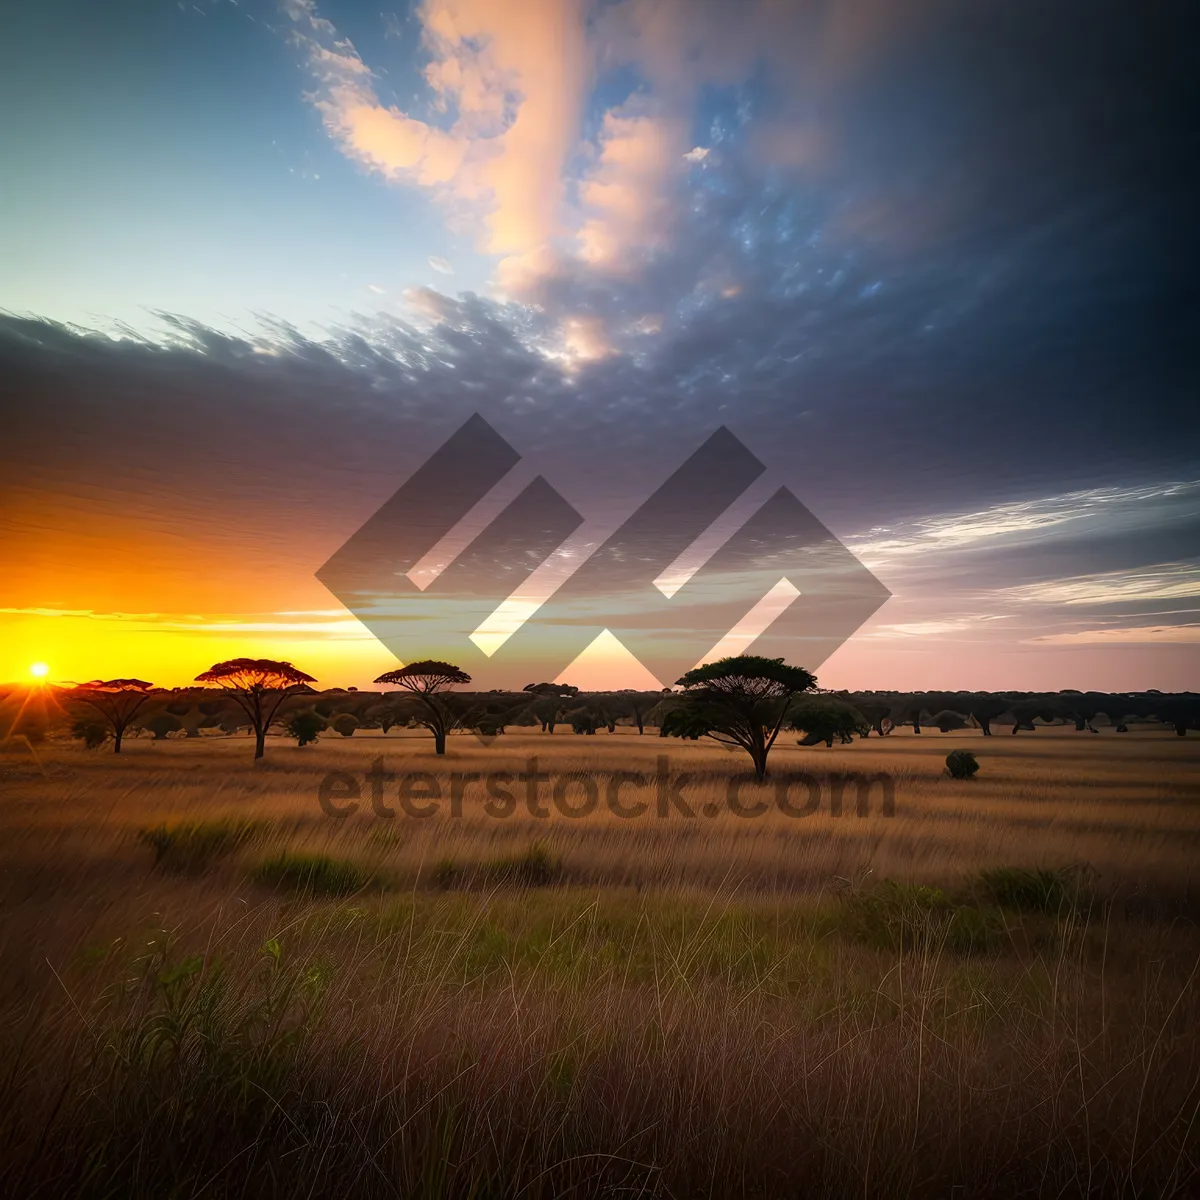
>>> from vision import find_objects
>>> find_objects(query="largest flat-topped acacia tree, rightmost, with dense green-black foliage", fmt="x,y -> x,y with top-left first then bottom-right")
664,654 -> 816,781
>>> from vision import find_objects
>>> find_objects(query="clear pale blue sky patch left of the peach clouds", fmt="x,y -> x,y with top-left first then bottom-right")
0,0 -> 487,328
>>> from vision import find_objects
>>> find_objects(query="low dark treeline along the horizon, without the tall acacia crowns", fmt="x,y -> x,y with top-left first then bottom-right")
0,680 -> 1200,752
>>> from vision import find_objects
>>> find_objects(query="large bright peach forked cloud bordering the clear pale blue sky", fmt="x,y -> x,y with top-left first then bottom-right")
283,0 -> 589,265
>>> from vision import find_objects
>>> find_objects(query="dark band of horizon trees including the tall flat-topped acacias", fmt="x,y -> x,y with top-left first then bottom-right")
0,655 -> 1200,779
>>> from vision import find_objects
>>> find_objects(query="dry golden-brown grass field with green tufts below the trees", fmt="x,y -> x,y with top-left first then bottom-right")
0,728 -> 1200,1198
